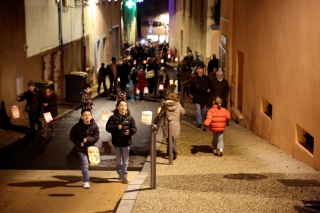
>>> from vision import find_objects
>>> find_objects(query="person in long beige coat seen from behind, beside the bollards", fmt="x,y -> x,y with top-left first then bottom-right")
153,90 -> 185,160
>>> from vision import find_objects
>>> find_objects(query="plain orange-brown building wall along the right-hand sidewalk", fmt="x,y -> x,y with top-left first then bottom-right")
221,0 -> 320,169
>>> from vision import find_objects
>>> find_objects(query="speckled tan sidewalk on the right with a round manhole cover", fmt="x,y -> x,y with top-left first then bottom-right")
117,103 -> 320,213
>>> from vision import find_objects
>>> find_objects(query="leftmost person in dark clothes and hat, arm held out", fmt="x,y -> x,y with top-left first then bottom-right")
17,81 -> 42,136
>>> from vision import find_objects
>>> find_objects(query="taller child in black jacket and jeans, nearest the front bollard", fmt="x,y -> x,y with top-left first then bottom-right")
106,99 -> 137,183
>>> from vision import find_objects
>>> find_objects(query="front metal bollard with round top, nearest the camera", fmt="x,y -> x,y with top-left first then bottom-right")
150,124 -> 157,189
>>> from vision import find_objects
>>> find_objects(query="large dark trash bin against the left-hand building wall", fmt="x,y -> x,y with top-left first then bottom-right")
65,74 -> 86,103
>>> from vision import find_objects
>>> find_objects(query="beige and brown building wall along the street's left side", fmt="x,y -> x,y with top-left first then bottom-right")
0,0 -> 121,124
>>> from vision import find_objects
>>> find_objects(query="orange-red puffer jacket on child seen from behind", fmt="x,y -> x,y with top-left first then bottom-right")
203,105 -> 231,132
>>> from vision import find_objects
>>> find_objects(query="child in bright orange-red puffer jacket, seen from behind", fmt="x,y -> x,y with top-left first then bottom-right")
203,96 -> 231,157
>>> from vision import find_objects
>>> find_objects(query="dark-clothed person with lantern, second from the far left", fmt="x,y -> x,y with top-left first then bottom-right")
42,86 -> 58,138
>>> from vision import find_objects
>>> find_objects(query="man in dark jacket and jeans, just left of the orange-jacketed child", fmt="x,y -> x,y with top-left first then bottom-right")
189,65 -> 212,128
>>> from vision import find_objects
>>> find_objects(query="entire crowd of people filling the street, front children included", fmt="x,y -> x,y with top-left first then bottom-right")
17,47 -> 230,189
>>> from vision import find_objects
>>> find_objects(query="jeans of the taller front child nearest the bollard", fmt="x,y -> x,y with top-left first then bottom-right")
115,146 -> 130,178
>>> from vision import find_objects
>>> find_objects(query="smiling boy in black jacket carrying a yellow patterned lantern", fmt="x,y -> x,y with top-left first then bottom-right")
70,109 -> 99,189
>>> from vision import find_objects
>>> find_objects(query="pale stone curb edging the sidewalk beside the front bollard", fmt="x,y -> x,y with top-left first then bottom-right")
116,126 -> 163,213
